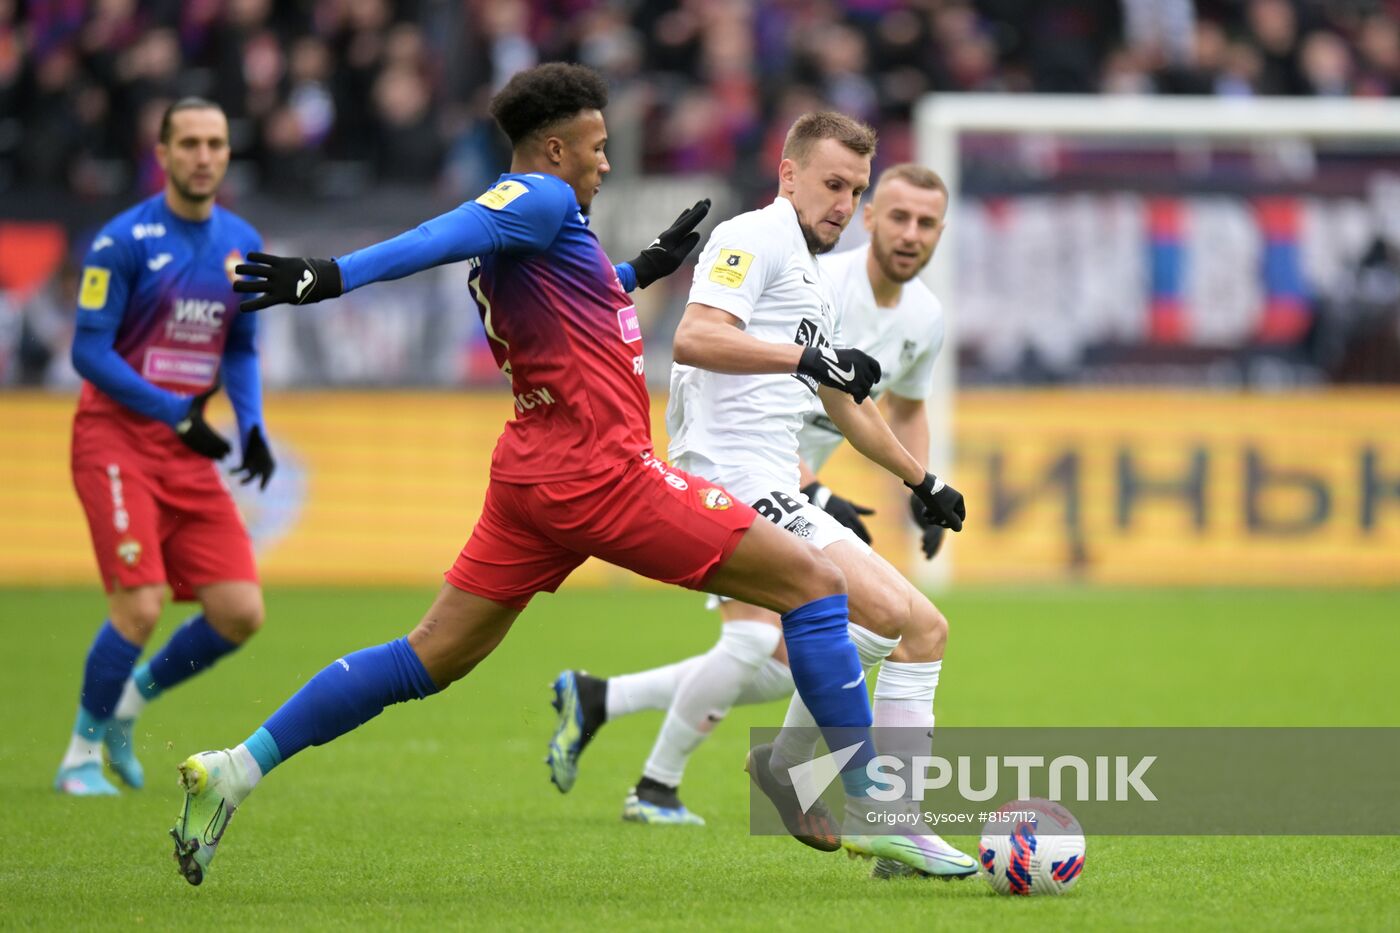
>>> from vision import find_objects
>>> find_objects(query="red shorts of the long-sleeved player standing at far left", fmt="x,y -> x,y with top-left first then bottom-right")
73,444 -> 258,601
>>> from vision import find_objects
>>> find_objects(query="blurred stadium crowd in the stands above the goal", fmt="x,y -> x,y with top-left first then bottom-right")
0,0 -> 1400,198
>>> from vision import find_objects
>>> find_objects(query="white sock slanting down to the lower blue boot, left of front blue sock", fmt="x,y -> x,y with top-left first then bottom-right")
641,622 -> 783,787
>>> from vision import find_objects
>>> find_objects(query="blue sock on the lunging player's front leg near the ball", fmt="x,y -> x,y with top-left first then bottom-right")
783,594 -> 875,794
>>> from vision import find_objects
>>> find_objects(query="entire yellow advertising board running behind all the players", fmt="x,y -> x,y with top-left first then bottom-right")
0,391 -> 1400,587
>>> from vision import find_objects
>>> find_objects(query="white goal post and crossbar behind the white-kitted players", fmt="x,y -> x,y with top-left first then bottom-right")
913,94 -> 1400,586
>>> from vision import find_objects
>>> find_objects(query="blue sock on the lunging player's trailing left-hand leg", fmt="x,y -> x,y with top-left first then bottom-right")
244,637 -> 436,775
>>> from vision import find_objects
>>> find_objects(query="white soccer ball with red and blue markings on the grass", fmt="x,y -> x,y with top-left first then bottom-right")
977,797 -> 1084,895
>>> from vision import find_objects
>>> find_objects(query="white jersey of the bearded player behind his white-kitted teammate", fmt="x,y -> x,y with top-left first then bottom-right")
798,247 -> 944,471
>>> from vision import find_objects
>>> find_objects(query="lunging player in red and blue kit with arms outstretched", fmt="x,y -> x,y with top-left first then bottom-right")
171,63 -> 912,884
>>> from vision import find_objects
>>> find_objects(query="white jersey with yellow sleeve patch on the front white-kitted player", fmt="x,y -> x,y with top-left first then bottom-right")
666,198 -> 844,490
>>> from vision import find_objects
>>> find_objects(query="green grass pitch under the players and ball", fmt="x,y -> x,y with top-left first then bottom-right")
0,588 -> 1400,932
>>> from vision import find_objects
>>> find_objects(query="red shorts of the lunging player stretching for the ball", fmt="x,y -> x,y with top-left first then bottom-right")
444,454 -> 757,609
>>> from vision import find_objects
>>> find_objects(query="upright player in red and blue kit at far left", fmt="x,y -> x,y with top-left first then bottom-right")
55,98 -> 274,796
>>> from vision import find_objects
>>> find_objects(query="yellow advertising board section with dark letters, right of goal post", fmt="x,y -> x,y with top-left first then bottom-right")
955,391 -> 1400,584
